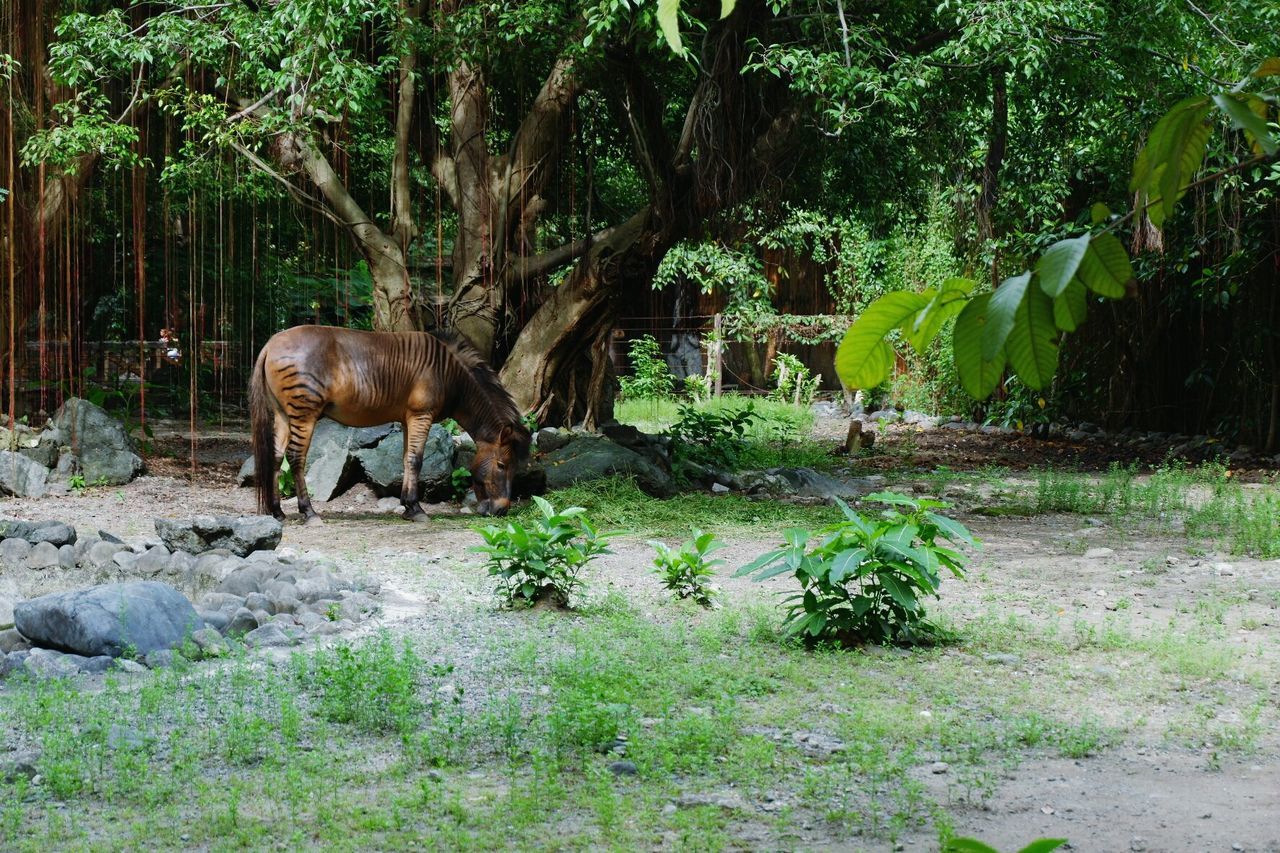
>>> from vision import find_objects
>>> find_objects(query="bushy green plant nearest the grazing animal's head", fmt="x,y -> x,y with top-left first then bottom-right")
472,496 -> 612,607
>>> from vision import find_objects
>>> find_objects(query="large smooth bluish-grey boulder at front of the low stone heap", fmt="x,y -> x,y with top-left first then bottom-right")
13,580 -> 204,657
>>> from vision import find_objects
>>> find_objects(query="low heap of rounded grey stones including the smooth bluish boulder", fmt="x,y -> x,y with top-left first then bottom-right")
0,516 -> 379,676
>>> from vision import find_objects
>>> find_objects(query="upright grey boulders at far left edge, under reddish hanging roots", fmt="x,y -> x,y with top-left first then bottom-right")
0,397 -> 143,498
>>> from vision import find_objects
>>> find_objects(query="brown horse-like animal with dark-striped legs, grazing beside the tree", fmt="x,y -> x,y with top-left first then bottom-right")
250,325 -> 530,524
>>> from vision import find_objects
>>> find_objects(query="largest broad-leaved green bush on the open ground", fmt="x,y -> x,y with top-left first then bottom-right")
735,492 -> 978,646
